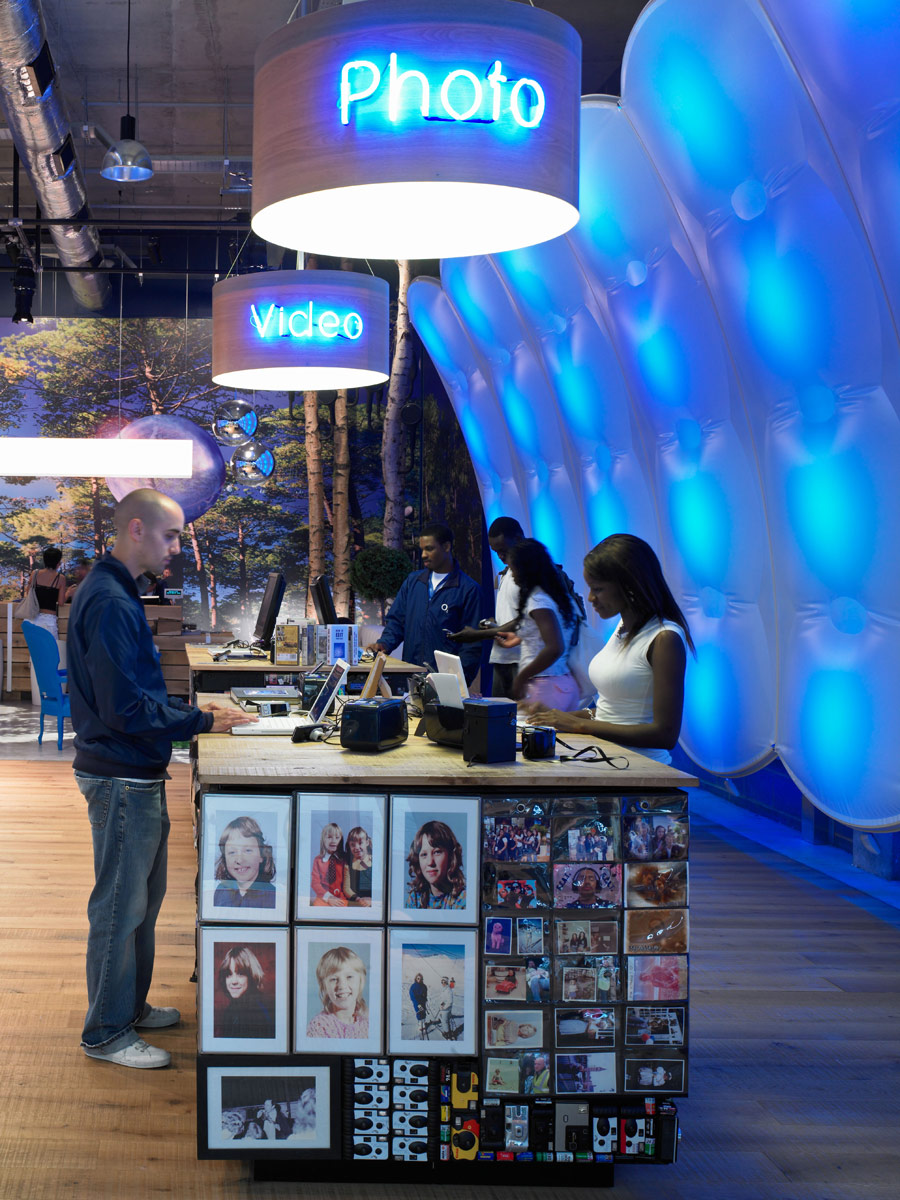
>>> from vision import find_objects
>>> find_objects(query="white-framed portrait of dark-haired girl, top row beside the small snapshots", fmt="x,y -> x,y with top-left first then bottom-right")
390,796 -> 481,925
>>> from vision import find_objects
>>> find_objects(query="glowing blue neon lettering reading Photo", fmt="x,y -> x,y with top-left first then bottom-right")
338,52 -> 547,130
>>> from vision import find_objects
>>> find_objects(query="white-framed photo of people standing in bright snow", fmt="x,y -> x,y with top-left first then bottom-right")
388,928 -> 478,1056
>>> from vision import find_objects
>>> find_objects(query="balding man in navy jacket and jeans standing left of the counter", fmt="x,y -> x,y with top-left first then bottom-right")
66,487 -> 254,1067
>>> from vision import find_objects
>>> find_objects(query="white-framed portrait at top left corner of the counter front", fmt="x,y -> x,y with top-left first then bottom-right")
198,792 -> 293,925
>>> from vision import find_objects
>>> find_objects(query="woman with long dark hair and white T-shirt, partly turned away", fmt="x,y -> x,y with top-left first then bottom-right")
496,538 -> 578,712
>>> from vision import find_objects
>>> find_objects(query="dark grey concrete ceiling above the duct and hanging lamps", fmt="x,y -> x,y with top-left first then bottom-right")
0,0 -> 644,230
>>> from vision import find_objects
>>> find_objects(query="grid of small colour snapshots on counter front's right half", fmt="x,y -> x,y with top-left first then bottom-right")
480,793 -> 690,1097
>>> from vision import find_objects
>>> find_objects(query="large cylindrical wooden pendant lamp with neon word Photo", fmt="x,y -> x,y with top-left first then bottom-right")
252,0 -> 581,258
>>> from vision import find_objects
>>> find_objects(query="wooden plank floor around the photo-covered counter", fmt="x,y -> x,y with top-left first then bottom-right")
0,762 -> 900,1200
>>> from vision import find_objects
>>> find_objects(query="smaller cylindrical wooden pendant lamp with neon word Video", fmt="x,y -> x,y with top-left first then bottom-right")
212,271 -> 390,391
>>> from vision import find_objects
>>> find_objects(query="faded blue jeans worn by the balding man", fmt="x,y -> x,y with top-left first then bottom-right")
76,772 -> 169,1051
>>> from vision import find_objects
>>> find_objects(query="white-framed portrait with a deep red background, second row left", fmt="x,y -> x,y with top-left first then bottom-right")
198,925 -> 290,1055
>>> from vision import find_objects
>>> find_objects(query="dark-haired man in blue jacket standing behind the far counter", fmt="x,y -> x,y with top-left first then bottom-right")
370,524 -> 484,683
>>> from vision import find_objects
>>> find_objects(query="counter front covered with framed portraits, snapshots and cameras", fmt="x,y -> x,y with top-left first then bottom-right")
198,788 -> 689,1187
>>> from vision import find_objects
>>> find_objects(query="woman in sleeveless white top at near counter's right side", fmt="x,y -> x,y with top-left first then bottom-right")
530,533 -> 694,762
